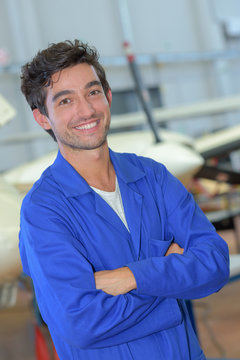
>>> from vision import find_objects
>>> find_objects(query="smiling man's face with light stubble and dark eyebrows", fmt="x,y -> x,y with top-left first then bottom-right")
41,63 -> 112,151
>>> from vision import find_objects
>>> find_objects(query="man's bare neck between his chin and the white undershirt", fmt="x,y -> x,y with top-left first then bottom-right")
60,142 -> 116,191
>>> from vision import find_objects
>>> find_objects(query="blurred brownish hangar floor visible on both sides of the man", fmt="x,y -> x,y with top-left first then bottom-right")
0,229 -> 240,360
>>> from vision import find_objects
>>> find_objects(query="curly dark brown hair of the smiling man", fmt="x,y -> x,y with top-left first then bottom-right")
21,40 -> 110,141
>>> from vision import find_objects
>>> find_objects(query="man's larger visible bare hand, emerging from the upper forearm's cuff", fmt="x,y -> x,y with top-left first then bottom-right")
94,267 -> 137,296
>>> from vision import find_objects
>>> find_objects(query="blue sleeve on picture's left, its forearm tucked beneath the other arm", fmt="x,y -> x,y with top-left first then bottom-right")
20,203 -> 181,348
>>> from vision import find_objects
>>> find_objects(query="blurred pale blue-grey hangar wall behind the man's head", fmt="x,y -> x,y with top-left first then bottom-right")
0,0 -> 240,170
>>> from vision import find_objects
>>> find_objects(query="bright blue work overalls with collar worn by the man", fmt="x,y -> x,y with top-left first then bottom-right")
19,151 -> 229,360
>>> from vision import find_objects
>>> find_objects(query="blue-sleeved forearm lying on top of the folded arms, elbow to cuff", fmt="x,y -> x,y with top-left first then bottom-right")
128,244 -> 229,299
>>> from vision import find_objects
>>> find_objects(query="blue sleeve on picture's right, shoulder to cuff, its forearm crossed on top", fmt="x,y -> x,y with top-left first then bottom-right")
128,165 -> 229,299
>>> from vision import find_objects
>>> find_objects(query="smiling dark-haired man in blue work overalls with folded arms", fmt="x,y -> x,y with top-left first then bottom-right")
20,40 -> 229,360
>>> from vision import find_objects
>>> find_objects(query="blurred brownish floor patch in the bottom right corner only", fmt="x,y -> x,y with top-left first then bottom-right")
194,281 -> 240,359
